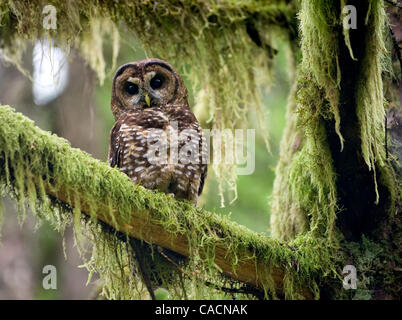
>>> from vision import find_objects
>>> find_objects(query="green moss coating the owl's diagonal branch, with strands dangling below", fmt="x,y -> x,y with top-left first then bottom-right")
0,106 -> 334,299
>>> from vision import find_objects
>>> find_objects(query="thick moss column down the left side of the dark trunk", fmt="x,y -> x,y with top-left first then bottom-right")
271,1 -> 343,243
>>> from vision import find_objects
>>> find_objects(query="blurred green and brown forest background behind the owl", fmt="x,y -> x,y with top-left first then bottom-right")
0,40 -> 290,299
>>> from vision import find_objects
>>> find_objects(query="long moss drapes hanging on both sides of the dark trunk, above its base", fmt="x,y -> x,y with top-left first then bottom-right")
271,0 -> 396,243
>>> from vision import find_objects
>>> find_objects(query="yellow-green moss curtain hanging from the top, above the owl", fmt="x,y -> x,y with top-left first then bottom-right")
0,0 -> 297,205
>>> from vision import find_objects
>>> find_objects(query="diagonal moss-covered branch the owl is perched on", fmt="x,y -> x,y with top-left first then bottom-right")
0,106 -> 325,298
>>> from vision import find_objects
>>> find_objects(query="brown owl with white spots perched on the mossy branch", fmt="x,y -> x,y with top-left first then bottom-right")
108,59 -> 207,203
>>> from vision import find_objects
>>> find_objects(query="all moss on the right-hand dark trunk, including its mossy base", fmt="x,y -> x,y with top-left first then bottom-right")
271,4 -> 400,299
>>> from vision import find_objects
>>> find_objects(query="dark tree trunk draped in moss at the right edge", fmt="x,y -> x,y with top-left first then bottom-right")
272,0 -> 401,299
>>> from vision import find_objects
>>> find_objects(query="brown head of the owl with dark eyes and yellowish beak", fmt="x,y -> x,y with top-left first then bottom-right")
111,59 -> 187,120
